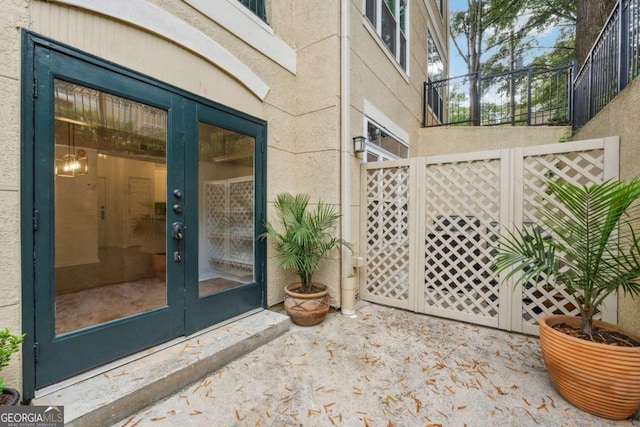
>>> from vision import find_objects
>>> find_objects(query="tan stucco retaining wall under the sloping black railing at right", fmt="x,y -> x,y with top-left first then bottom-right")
573,79 -> 640,334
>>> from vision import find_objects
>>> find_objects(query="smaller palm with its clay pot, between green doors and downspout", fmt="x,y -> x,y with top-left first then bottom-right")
260,193 -> 351,326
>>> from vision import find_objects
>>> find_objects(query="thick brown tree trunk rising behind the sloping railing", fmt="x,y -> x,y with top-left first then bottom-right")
576,0 -> 617,67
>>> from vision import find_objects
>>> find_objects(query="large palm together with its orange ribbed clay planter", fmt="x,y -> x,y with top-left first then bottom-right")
494,178 -> 640,419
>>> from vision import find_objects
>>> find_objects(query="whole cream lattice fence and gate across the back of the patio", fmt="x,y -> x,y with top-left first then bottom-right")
360,137 -> 619,334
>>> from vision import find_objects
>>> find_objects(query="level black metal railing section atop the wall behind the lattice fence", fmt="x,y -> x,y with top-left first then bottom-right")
422,65 -> 574,127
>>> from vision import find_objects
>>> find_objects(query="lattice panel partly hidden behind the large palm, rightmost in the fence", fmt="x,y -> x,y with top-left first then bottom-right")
522,149 -> 605,328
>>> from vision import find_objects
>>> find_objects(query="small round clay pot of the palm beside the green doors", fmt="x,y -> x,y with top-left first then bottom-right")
284,282 -> 329,326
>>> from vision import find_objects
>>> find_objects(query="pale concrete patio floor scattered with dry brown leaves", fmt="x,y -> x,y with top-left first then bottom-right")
115,302 -> 640,427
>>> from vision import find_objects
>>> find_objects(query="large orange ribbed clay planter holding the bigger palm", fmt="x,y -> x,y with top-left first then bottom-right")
539,315 -> 640,420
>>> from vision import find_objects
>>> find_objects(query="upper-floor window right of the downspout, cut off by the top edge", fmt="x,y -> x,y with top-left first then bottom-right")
365,0 -> 408,70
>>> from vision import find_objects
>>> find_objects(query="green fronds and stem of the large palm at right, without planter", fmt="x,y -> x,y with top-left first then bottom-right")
494,178 -> 640,335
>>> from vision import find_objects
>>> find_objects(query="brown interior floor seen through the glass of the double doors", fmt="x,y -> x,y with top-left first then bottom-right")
56,277 -> 241,334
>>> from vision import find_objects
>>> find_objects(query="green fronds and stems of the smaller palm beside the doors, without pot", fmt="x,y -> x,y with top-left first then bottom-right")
260,193 -> 351,293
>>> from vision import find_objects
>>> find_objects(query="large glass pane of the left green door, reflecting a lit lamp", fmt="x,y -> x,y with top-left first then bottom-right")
54,79 -> 167,334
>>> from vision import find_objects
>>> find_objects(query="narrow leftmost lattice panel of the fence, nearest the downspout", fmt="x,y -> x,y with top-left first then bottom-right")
364,166 -> 409,308
